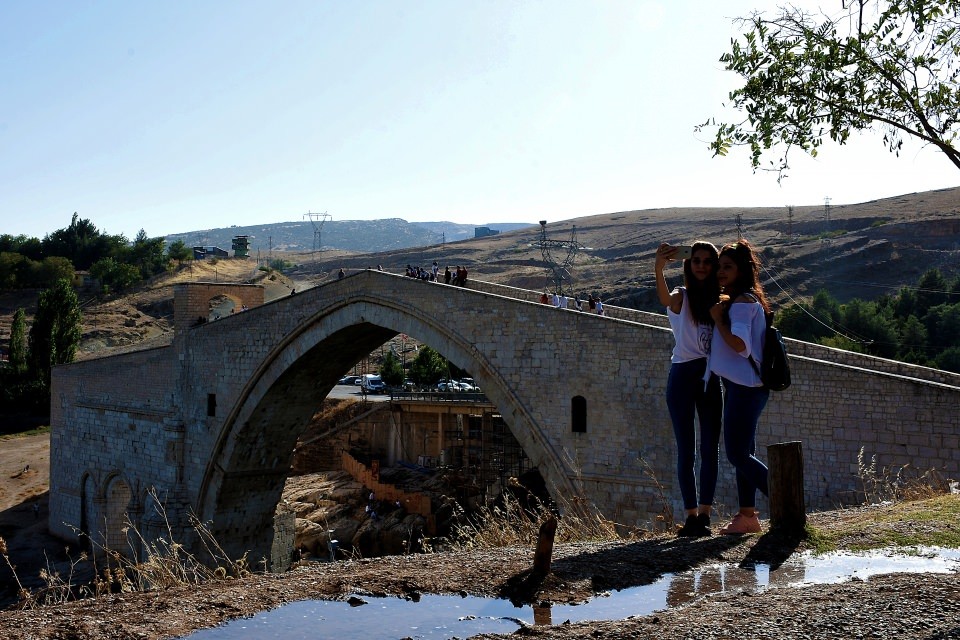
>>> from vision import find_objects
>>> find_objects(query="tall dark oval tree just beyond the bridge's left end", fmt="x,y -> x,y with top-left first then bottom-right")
29,279 -> 82,389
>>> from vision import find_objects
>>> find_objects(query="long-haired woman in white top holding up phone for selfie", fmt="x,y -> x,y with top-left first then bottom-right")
653,242 -> 723,538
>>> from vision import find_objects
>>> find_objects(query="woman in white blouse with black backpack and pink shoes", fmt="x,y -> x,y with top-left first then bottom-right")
710,240 -> 770,534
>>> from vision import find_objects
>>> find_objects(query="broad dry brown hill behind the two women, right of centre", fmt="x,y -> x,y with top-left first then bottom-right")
297,189 -> 960,309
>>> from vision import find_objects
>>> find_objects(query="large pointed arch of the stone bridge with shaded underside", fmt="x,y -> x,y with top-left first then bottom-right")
199,293 -> 575,552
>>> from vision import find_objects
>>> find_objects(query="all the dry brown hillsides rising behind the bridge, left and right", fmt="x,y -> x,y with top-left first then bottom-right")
0,188 -> 960,358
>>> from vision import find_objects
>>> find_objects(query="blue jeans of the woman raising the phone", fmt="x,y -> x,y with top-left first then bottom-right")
667,358 -> 723,509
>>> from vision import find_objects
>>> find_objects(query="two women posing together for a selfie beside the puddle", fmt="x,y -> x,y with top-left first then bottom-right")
654,240 -> 770,537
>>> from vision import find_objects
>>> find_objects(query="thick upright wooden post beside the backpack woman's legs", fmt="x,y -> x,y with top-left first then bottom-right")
767,442 -> 807,535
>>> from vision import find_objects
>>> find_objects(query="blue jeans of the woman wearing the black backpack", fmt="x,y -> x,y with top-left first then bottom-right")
723,378 -> 770,509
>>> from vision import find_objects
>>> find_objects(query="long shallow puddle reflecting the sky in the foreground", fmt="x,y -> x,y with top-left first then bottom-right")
185,548 -> 960,640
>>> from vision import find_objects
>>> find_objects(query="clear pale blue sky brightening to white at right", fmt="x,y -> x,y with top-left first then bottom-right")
0,0 -> 960,238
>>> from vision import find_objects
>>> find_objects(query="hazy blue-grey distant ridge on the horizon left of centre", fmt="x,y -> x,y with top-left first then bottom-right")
166,218 -> 534,255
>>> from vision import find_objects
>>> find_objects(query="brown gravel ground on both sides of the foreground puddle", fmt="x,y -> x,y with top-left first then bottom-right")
0,510 -> 960,640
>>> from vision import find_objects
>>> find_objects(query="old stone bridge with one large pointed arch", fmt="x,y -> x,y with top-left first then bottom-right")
50,270 -> 960,569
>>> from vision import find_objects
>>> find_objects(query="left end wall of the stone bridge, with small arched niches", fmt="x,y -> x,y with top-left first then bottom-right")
50,347 -> 183,540
